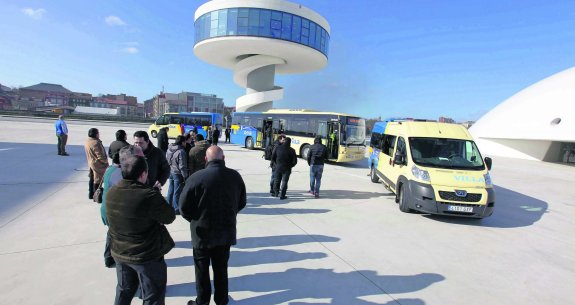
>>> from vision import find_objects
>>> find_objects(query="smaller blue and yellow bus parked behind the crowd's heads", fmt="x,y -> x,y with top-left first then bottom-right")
148,112 -> 222,139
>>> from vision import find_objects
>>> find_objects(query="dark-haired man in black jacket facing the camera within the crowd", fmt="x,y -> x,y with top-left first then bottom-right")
134,130 -> 170,190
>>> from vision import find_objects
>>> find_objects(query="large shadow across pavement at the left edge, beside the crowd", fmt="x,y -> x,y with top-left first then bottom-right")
0,142 -> 88,227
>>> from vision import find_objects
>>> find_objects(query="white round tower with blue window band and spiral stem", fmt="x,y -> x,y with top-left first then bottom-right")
194,0 -> 330,111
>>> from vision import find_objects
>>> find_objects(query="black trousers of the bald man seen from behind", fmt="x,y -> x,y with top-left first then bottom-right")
194,246 -> 230,305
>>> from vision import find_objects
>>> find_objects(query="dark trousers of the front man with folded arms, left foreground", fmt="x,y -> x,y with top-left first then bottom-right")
114,257 -> 168,305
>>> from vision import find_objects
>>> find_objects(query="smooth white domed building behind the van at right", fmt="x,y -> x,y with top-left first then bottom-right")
469,67 -> 575,163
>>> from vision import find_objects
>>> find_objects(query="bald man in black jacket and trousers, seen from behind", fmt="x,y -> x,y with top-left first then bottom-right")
179,146 -> 246,305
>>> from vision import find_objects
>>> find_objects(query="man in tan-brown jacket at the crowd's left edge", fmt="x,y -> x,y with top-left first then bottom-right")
84,128 -> 109,199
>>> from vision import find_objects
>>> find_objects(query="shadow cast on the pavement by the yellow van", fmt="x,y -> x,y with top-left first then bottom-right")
426,186 -> 548,228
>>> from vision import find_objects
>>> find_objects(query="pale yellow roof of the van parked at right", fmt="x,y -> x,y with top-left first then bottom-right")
373,121 -> 473,140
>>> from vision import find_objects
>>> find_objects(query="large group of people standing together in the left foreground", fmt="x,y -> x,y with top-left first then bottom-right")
79,123 -> 246,305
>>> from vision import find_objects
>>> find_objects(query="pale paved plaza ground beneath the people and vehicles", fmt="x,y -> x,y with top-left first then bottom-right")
0,117 -> 575,305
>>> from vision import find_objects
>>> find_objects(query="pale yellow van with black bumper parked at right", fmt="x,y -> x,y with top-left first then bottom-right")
368,120 -> 495,218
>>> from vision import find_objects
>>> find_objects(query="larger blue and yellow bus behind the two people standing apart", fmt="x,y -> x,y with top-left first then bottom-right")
230,109 -> 365,162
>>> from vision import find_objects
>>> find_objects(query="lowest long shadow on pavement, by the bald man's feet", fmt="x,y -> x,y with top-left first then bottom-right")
168,268 -> 445,305
